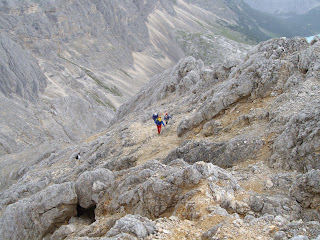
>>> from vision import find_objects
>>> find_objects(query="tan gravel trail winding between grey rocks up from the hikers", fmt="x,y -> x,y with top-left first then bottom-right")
75,94 -> 284,240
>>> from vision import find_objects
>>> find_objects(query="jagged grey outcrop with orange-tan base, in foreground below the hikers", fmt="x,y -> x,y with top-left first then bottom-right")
102,161 -> 239,223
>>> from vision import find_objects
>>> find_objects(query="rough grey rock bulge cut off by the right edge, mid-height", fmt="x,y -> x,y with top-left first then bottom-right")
270,105 -> 320,172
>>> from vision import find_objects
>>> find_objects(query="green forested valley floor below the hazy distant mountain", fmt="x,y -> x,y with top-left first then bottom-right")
204,0 -> 320,44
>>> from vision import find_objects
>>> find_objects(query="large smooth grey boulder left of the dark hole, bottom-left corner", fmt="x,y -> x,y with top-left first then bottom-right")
0,182 -> 77,239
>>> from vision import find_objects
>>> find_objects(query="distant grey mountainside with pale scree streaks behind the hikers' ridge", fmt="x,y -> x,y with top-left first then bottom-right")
0,0 -> 260,159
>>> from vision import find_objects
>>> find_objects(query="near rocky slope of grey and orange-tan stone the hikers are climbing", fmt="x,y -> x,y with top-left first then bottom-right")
0,38 -> 320,239
